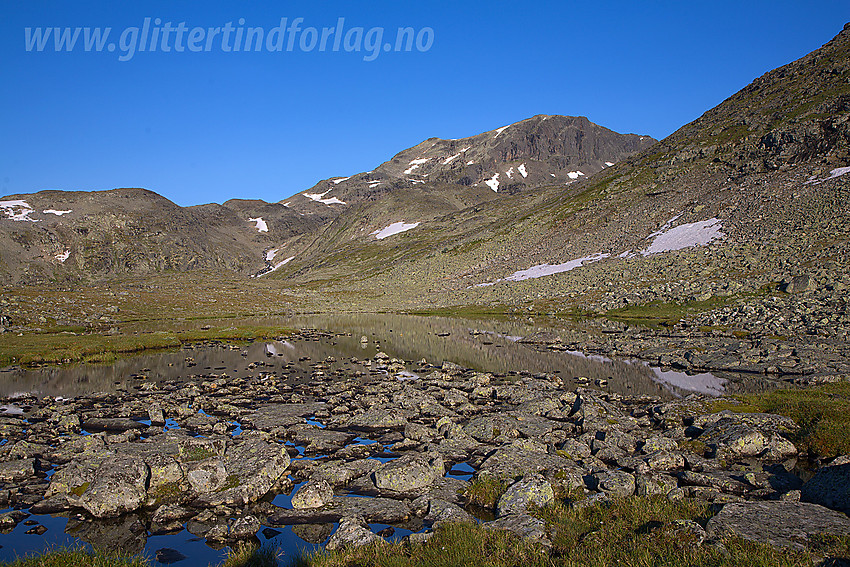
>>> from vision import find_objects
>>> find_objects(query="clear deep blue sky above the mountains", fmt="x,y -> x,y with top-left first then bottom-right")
0,0 -> 850,205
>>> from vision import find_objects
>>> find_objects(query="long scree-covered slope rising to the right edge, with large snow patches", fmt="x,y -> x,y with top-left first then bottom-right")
260,24 -> 850,312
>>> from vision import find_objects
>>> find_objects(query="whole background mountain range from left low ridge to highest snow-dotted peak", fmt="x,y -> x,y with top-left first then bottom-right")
0,116 -> 654,283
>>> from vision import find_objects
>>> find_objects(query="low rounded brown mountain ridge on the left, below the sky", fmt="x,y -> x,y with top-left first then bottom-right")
0,189 -> 321,284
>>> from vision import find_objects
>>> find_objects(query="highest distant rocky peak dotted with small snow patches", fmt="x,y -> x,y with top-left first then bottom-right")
283,115 -> 655,216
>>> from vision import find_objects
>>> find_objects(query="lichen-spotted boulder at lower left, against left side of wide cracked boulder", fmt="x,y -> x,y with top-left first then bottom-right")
80,456 -> 150,518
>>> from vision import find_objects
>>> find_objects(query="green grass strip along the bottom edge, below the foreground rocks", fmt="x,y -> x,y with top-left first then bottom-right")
294,497 -> 850,567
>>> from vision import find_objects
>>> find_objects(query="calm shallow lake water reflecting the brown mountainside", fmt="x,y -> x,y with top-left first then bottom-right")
0,314 -> 725,398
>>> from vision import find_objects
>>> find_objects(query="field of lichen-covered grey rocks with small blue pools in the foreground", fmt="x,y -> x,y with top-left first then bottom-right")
0,333 -> 850,552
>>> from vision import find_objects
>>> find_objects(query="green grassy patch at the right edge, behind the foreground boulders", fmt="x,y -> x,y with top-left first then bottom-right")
712,382 -> 850,457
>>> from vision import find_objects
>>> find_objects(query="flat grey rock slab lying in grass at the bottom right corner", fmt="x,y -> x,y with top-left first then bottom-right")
706,501 -> 850,550
